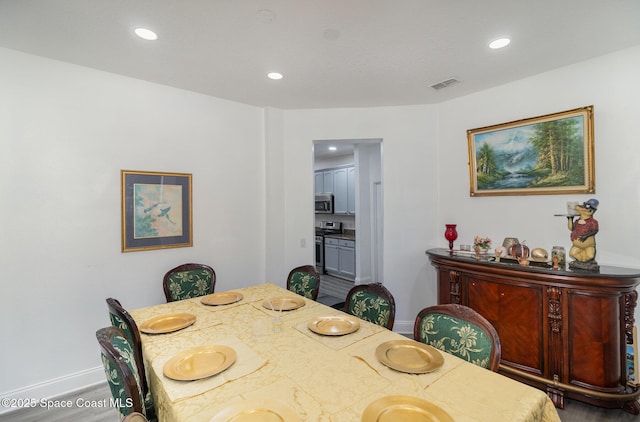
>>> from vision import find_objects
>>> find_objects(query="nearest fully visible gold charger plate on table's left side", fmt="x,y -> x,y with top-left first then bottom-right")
162,346 -> 236,381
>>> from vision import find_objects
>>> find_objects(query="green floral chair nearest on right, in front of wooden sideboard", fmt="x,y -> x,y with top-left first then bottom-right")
413,304 -> 502,372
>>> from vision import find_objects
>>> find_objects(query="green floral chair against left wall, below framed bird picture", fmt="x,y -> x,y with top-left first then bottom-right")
162,263 -> 216,302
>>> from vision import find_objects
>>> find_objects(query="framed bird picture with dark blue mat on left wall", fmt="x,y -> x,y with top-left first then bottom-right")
121,170 -> 193,252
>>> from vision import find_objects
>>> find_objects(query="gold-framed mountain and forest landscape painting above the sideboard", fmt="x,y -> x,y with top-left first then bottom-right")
467,106 -> 595,196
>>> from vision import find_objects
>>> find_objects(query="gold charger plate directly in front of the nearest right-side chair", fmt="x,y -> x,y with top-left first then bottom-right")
376,340 -> 444,374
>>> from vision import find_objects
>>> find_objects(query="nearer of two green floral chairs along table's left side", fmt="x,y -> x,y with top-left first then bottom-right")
96,326 -> 151,419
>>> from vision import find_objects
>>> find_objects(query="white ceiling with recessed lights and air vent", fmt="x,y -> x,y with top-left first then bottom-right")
0,0 -> 640,109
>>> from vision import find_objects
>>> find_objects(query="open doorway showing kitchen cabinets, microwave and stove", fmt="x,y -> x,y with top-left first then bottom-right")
313,139 -> 384,301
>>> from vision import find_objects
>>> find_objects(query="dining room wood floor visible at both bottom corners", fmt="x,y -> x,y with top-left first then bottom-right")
0,382 -> 640,422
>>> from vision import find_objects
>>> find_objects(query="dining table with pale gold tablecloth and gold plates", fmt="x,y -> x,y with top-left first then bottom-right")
130,283 -> 560,422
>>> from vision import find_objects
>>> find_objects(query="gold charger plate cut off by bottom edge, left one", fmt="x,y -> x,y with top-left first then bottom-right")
210,399 -> 300,422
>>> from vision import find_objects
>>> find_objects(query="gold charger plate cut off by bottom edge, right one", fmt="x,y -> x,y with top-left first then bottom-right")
362,396 -> 454,422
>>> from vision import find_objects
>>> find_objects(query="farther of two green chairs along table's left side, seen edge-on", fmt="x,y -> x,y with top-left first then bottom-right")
107,298 -> 156,419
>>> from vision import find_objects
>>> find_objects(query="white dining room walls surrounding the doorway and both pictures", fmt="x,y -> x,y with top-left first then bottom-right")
0,42 -> 640,402
